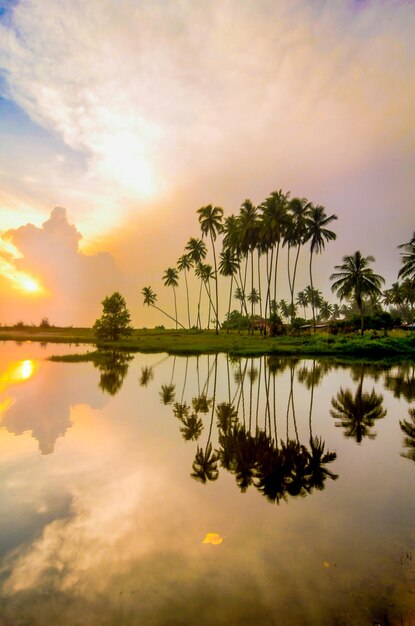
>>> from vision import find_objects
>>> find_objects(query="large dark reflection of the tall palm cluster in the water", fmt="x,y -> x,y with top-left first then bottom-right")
160,356 -> 337,502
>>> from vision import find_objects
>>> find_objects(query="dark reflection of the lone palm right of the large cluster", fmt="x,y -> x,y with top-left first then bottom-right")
330,367 -> 386,443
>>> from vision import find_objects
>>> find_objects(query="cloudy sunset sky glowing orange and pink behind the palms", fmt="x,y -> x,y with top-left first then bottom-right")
0,0 -> 415,326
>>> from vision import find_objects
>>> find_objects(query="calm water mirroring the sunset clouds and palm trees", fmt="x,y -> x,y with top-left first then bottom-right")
0,342 -> 415,626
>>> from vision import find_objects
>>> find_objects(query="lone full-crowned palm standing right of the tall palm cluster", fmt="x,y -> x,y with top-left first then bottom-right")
330,250 -> 385,335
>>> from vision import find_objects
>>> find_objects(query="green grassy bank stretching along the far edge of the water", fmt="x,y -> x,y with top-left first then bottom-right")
0,327 -> 415,359
